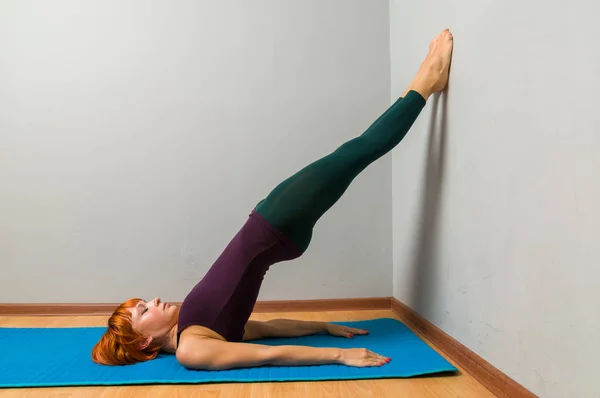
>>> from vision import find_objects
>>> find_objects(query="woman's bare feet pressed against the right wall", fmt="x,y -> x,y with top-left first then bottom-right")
404,29 -> 454,100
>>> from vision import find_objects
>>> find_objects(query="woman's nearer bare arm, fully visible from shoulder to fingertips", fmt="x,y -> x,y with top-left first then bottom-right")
176,337 -> 389,370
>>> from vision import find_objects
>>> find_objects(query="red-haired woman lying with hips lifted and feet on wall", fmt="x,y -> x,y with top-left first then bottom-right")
92,29 -> 453,370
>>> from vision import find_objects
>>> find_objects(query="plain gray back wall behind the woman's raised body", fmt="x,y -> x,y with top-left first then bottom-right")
0,0 -> 392,302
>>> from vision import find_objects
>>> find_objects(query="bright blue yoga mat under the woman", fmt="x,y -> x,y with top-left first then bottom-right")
0,318 -> 457,387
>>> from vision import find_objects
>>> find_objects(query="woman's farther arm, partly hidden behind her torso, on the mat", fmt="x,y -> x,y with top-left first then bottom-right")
244,319 -> 369,340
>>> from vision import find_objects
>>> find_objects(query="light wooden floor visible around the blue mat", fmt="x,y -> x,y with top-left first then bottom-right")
0,310 -> 494,398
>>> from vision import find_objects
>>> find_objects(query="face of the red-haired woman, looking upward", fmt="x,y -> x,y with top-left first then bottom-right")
130,297 -> 178,339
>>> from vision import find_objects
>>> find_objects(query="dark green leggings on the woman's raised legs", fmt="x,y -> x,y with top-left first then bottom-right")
256,91 -> 425,251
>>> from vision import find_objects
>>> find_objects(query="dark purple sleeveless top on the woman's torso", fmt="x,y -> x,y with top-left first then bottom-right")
177,210 -> 302,342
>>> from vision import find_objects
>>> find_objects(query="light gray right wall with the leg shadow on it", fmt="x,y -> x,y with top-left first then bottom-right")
391,0 -> 600,397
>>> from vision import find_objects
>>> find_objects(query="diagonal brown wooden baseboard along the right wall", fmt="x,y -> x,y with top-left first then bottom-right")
390,297 -> 537,398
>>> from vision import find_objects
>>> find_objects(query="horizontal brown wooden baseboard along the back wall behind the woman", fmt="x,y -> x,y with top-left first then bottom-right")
0,297 -> 390,316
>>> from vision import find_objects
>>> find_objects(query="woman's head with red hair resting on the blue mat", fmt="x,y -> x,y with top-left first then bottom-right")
92,297 -> 178,365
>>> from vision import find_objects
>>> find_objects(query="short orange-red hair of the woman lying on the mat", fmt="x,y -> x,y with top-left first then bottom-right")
92,298 -> 161,365
